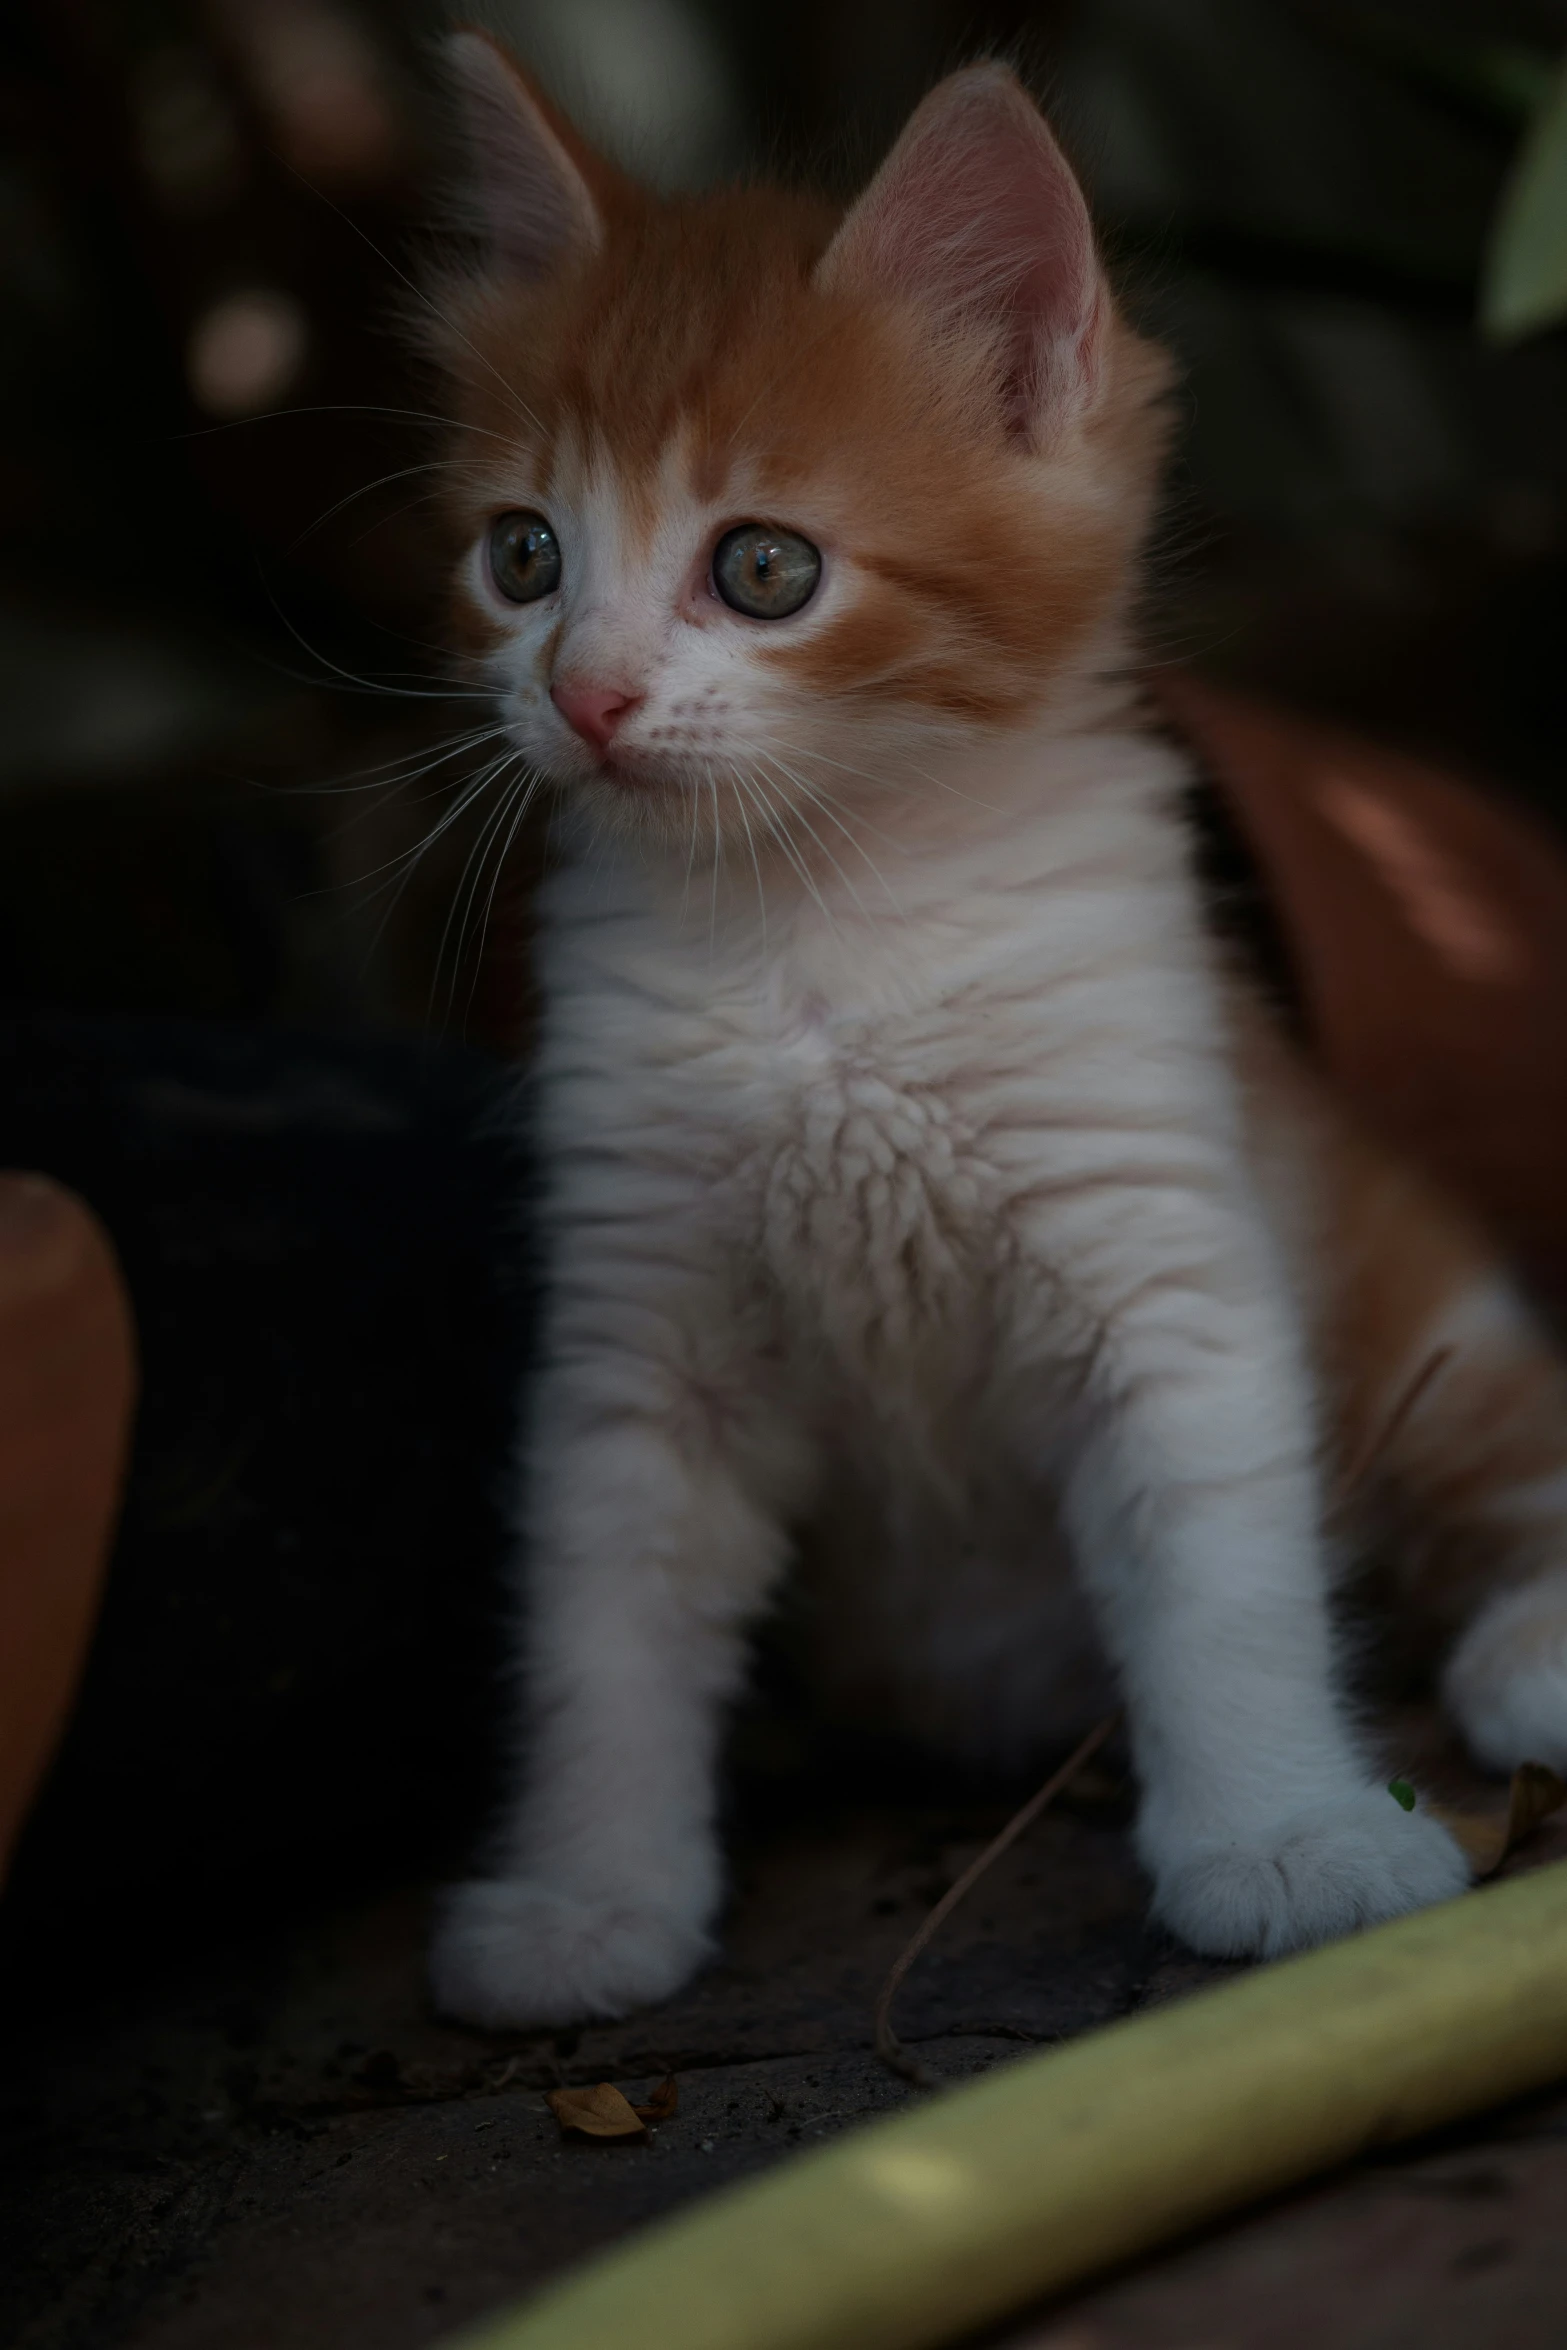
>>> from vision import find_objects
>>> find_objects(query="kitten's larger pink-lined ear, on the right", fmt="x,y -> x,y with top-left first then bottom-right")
818,66 -> 1109,442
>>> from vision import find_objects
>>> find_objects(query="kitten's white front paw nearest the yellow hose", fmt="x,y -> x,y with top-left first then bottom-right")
1154,1786 -> 1471,1958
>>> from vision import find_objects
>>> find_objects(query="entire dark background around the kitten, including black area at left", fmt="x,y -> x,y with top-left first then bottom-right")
0,0 -> 1567,1918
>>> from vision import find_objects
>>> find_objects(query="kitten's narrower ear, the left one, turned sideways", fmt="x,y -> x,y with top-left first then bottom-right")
446,33 -> 604,277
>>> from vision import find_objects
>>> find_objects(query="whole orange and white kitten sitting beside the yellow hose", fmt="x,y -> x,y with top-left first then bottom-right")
422,35 -> 1567,2026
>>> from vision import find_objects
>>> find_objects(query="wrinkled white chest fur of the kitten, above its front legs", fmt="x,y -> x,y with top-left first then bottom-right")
540,723 -> 1231,1398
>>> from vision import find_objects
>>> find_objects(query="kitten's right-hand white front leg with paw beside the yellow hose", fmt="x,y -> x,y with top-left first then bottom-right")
1043,1194 -> 1468,1958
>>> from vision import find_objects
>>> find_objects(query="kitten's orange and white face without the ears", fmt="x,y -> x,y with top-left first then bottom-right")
434,55 -> 1169,855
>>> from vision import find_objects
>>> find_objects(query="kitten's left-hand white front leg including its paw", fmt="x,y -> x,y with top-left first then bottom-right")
432,1316 -> 787,2026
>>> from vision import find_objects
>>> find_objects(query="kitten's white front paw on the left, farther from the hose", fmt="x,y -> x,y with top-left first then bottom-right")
430,1878 -> 712,2030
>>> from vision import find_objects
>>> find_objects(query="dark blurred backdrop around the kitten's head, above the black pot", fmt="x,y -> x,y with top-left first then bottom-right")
0,0 -> 1567,1039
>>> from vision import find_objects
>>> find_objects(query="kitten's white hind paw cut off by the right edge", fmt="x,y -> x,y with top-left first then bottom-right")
1442,1575 -> 1567,1772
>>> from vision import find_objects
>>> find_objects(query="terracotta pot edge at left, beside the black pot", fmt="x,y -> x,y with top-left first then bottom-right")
0,1175 -> 136,1873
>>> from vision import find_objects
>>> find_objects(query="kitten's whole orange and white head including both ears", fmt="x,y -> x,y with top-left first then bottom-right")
439,33 -> 1165,851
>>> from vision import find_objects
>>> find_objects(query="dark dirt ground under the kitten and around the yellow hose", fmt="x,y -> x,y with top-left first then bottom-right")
0,1720 -> 1567,2350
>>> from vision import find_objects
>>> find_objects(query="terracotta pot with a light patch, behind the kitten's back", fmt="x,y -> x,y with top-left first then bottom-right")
1161,679 -> 1567,1309
